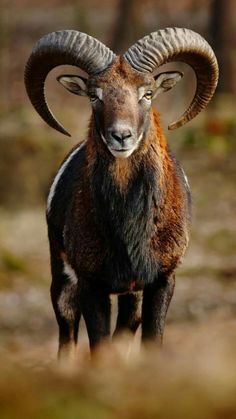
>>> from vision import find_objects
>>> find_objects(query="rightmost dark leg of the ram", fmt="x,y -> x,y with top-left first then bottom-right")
142,274 -> 175,345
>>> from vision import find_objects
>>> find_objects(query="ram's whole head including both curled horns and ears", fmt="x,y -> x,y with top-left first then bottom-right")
25,28 -> 218,157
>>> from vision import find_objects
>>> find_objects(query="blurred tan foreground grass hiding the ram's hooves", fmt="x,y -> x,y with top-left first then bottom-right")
0,319 -> 236,419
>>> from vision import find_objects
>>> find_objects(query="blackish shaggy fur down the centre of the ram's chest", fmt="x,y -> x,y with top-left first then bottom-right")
89,159 -> 159,288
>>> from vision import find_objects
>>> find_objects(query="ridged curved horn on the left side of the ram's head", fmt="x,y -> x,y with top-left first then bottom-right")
25,30 -> 115,136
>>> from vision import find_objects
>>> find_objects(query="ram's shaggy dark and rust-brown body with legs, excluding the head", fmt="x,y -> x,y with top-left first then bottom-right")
47,59 -> 190,353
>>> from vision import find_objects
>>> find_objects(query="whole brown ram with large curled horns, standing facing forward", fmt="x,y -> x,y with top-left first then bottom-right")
25,28 -> 218,356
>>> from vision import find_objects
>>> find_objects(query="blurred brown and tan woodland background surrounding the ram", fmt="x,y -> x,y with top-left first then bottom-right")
0,0 -> 236,418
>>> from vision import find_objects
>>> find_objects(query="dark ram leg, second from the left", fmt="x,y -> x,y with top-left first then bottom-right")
81,280 -> 111,351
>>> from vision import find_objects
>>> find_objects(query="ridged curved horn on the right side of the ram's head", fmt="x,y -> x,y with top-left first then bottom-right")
124,28 -> 219,129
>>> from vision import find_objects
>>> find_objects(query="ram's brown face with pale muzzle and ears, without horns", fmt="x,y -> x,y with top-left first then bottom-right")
58,58 -> 181,158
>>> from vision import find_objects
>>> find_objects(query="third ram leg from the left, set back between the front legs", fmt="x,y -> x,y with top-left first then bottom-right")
113,292 -> 142,337
